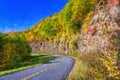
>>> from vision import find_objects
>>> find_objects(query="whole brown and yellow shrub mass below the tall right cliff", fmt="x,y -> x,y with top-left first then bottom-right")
82,50 -> 120,80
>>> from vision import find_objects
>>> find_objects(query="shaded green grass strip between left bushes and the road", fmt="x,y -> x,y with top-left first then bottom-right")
0,54 -> 53,76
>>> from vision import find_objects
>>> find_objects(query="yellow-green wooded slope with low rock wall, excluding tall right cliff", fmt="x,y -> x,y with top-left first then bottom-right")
20,0 -> 97,53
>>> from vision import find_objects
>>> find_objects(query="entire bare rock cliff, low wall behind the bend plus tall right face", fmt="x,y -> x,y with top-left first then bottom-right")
31,0 -> 120,53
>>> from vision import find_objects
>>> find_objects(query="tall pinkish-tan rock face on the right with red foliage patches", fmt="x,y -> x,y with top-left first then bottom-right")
79,0 -> 120,53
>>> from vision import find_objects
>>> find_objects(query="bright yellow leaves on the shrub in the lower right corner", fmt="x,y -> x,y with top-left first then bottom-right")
98,51 -> 120,80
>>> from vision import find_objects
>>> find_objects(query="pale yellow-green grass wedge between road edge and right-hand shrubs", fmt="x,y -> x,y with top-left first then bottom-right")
67,58 -> 88,80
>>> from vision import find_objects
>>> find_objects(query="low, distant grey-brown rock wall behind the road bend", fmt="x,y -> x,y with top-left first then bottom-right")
30,39 -> 78,54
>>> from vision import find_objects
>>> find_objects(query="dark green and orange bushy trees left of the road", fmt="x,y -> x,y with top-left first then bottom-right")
0,34 -> 31,70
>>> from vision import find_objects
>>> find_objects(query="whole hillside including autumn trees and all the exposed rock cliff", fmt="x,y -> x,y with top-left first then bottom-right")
18,0 -> 119,53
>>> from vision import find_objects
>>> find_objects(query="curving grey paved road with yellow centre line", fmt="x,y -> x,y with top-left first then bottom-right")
0,56 -> 74,80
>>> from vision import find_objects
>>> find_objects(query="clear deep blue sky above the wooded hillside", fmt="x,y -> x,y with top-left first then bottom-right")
0,0 -> 68,32
